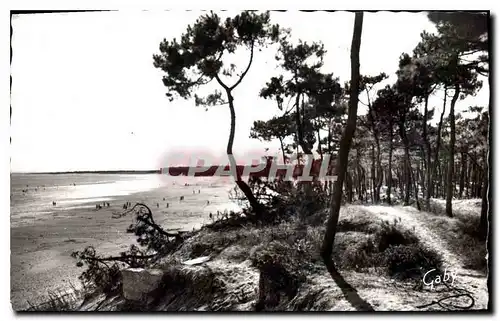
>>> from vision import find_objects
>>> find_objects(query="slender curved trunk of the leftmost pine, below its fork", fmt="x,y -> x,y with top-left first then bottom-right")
226,90 -> 264,218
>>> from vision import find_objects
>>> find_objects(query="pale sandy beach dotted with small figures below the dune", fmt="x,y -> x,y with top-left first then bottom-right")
11,174 -> 238,310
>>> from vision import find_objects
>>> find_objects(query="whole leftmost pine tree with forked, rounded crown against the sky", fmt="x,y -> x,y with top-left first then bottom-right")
153,11 -> 280,217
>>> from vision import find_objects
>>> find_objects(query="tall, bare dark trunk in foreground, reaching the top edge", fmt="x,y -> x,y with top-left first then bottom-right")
321,12 -> 363,262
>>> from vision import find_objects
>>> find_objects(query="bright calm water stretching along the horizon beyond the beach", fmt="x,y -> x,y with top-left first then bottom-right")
10,174 -> 240,227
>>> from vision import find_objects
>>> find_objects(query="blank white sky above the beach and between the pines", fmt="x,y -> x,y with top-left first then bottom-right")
10,10 -> 489,172
